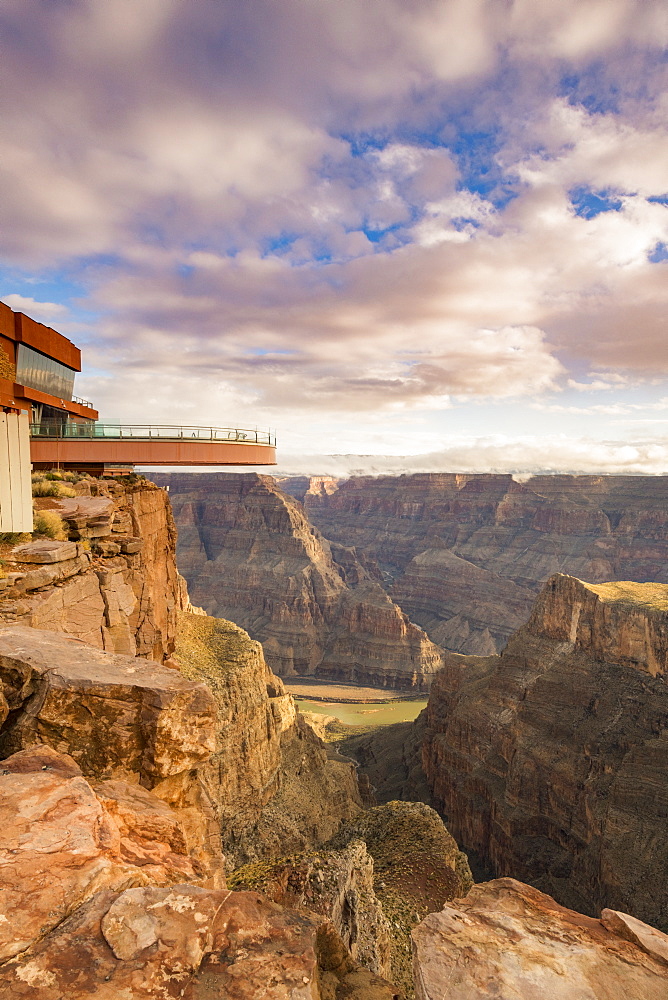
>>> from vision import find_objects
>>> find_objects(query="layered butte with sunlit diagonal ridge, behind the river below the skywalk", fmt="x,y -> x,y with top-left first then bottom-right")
156,473 -> 442,690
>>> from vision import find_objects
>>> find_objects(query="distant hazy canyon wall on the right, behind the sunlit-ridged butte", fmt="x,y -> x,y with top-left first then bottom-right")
300,473 -> 668,655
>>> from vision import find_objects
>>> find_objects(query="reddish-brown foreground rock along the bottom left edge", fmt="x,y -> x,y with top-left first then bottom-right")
0,885 -> 399,1000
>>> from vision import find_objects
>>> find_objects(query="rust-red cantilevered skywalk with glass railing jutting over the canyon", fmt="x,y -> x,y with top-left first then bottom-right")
30,422 -> 276,473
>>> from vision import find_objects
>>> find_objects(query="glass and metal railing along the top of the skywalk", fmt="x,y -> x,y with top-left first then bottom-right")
30,420 -> 276,445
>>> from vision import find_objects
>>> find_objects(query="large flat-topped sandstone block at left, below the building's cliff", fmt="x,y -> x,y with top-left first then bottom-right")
0,627 -> 215,787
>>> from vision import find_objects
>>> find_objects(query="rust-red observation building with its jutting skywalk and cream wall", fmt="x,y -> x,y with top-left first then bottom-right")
0,303 -> 276,531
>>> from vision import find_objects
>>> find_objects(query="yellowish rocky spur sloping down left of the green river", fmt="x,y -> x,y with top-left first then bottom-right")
171,614 -> 361,865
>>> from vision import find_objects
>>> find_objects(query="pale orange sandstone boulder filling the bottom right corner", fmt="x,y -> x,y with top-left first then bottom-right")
413,878 -> 668,1000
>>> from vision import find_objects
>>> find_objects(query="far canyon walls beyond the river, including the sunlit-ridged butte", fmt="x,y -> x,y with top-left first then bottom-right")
162,473 -> 668,668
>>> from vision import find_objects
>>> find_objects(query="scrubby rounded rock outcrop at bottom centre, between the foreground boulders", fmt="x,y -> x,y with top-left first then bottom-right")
230,802 -> 472,997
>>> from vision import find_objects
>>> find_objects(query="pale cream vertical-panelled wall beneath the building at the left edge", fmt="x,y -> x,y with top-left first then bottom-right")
0,413 -> 32,531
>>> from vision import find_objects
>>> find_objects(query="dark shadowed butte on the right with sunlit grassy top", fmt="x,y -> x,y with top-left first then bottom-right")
423,576 -> 668,928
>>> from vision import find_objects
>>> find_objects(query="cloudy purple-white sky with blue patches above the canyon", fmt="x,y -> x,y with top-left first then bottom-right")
0,0 -> 668,475
